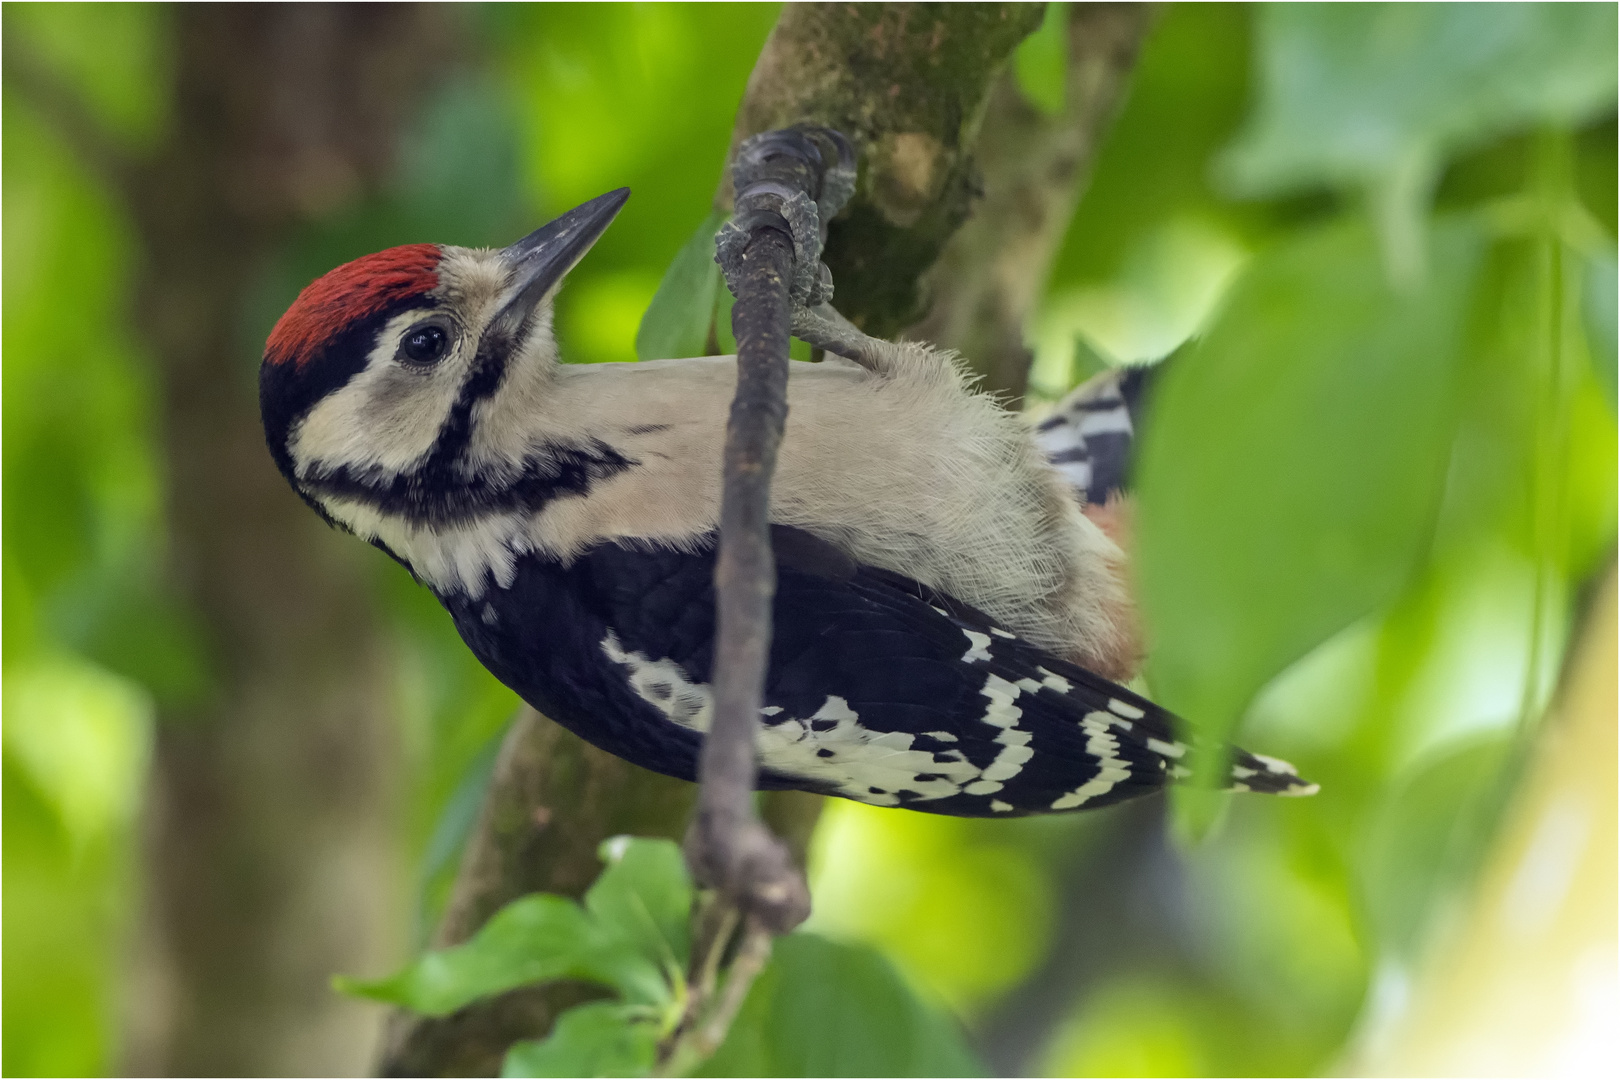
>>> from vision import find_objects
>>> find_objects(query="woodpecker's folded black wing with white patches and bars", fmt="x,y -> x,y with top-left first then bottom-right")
557,528 -> 1309,816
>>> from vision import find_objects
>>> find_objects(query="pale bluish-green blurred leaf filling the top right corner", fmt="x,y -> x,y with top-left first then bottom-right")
1218,3 -> 1615,196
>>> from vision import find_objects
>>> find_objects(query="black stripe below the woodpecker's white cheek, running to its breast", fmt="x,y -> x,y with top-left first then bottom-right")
300,437 -> 638,526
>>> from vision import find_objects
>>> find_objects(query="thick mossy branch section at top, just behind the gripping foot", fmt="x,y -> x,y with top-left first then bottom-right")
716,3 -> 1045,337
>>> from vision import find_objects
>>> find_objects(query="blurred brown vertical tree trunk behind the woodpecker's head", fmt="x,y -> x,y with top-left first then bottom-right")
109,5 -> 454,1075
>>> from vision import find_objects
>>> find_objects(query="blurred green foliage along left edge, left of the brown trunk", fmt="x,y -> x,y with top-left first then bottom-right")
0,8 -> 171,1075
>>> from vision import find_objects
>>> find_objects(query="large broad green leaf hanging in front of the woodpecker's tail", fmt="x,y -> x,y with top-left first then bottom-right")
1136,220 -> 1482,780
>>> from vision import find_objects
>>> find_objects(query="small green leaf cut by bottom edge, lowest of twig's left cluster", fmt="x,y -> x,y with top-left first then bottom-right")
501,1001 -> 658,1077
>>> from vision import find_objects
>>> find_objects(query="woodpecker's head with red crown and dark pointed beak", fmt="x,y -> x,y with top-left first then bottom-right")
259,188 -> 630,528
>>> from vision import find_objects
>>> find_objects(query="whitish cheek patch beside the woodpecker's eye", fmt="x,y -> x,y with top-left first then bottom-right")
288,311 -> 473,476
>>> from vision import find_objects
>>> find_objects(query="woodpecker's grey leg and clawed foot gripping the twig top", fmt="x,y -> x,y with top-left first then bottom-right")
714,126 -> 888,371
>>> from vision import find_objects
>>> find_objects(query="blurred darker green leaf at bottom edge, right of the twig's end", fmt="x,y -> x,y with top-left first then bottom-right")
695,934 -> 987,1077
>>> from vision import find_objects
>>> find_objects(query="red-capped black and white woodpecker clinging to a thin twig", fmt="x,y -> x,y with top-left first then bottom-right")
261,189 -> 1315,818
